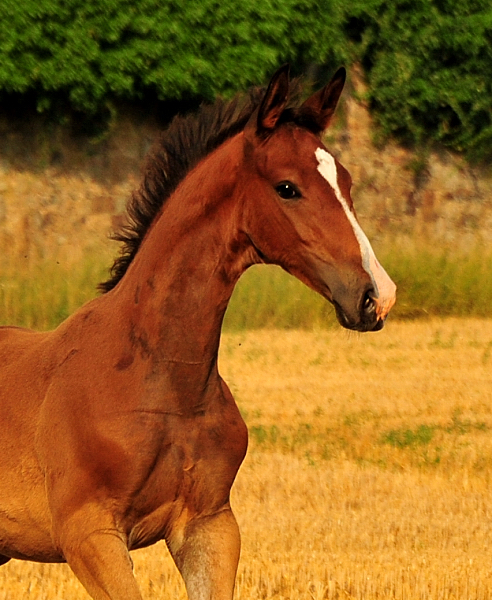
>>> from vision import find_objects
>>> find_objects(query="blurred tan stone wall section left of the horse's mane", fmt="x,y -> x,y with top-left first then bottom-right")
0,169 -> 132,263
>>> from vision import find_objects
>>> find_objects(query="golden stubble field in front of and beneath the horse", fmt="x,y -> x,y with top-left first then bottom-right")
0,319 -> 492,600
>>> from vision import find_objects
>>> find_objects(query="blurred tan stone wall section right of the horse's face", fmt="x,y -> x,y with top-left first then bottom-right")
333,72 -> 492,250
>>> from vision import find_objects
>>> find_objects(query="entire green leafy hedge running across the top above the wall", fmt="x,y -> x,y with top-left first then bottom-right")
0,0 -> 492,160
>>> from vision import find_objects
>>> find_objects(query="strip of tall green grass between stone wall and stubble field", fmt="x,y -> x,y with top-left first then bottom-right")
0,241 -> 492,330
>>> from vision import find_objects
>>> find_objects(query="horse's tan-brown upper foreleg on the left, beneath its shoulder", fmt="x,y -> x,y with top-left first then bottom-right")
58,529 -> 142,600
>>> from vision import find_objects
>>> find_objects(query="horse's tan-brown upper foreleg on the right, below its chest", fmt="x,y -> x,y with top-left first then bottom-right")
168,507 -> 240,600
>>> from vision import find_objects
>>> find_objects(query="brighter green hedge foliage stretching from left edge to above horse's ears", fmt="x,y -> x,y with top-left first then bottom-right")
0,0 -> 344,112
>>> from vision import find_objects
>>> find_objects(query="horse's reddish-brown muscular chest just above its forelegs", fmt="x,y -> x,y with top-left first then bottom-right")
124,400 -> 247,547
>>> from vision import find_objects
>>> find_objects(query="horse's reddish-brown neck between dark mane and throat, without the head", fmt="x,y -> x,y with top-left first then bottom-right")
115,135 -> 247,364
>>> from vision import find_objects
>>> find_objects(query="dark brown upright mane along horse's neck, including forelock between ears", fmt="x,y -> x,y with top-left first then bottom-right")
98,81 -> 319,293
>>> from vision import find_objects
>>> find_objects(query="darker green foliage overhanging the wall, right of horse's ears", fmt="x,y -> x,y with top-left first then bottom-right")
344,0 -> 492,159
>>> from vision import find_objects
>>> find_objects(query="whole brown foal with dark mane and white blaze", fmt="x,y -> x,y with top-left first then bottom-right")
0,67 -> 395,600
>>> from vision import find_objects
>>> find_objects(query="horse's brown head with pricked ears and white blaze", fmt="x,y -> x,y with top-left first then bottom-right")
238,67 -> 396,331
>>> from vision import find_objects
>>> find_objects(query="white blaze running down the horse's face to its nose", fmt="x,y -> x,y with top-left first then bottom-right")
315,148 -> 396,318
